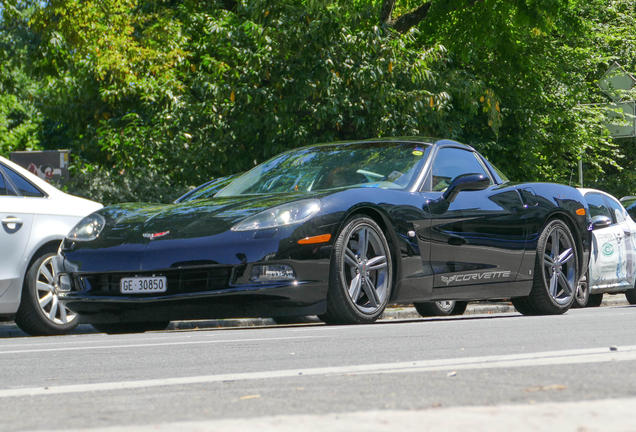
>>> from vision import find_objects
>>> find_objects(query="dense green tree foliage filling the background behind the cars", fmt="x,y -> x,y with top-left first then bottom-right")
0,0 -> 636,203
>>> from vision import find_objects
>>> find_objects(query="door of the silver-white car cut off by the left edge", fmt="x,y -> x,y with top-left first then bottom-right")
0,164 -> 33,295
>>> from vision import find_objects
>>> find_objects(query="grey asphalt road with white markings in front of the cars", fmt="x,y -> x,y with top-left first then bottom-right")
0,306 -> 636,432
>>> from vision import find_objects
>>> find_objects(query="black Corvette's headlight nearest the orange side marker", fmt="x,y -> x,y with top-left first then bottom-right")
232,199 -> 320,231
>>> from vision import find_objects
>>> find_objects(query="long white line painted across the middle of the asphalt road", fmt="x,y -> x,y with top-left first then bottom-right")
0,339 -> 636,398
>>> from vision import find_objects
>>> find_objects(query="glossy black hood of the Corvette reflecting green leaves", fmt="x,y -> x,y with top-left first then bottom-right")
99,194 -> 324,243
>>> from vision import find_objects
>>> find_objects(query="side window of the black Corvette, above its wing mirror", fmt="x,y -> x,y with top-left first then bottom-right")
425,147 -> 492,192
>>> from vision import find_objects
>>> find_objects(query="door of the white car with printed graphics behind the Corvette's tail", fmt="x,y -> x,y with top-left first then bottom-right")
585,192 -> 627,294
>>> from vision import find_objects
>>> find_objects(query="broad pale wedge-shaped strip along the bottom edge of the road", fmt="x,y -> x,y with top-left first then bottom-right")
29,398 -> 636,432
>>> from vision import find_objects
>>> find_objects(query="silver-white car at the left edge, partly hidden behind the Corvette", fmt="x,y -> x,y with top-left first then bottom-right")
0,157 -> 102,335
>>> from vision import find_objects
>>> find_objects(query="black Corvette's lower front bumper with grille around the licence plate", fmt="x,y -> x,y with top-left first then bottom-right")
57,259 -> 329,323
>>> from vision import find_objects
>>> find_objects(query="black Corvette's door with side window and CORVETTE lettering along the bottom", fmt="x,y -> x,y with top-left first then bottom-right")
419,147 -> 526,298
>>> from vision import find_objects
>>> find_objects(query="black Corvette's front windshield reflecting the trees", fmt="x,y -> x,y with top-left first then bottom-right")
216,142 -> 430,197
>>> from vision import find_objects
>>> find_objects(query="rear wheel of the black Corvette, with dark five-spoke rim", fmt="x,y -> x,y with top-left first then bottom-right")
512,219 -> 580,315
